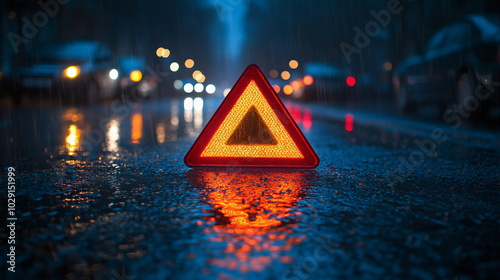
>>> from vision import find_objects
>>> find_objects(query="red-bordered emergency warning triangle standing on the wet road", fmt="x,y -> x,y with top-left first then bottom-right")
184,65 -> 319,168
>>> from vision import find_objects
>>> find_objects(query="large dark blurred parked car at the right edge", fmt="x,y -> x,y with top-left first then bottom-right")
393,15 -> 500,115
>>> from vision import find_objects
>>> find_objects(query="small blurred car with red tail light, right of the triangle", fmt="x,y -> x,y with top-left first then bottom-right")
296,62 -> 357,101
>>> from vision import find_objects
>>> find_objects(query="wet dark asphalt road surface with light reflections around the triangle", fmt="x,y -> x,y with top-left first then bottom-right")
0,95 -> 500,280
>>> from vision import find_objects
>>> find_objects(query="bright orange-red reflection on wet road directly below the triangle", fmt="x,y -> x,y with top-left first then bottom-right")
193,171 -> 307,272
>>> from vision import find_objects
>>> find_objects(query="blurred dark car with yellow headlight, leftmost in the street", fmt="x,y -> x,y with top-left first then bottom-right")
10,41 -> 117,104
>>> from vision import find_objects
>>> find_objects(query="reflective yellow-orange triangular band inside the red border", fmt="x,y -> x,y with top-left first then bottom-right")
201,81 -> 304,158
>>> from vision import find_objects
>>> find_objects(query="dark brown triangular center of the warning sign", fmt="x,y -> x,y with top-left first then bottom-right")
226,106 -> 278,145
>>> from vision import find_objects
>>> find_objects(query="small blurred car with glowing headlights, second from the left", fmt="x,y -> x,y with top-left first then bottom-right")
113,57 -> 158,100
